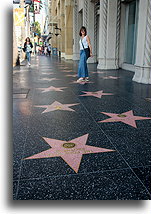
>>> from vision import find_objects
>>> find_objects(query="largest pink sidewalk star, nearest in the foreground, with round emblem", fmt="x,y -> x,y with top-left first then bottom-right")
25,134 -> 115,173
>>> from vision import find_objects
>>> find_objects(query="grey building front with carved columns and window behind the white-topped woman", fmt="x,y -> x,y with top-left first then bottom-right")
73,0 -> 151,84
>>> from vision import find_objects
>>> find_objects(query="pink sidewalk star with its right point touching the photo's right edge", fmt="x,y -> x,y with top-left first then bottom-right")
98,110 -> 151,128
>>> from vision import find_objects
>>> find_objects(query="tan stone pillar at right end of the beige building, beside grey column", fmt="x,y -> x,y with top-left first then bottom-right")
65,0 -> 73,59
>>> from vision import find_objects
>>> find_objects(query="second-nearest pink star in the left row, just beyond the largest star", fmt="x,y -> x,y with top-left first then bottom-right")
34,101 -> 79,114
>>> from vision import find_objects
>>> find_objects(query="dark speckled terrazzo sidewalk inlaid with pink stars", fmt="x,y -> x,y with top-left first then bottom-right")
13,56 -> 151,200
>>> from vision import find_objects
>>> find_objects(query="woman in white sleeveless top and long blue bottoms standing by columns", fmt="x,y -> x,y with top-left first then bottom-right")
77,26 -> 92,82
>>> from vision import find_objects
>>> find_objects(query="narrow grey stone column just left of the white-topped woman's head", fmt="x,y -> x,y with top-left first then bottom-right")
73,0 -> 80,60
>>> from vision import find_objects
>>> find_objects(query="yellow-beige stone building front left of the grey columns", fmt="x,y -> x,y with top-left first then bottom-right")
50,0 -> 73,59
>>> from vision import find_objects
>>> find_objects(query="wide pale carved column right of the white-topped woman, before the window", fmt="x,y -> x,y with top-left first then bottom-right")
97,0 -> 120,69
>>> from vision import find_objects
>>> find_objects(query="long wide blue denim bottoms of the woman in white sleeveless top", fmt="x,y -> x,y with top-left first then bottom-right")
78,50 -> 88,78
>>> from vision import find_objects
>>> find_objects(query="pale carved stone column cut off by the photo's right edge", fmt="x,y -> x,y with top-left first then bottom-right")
133,0 -> 151,84
